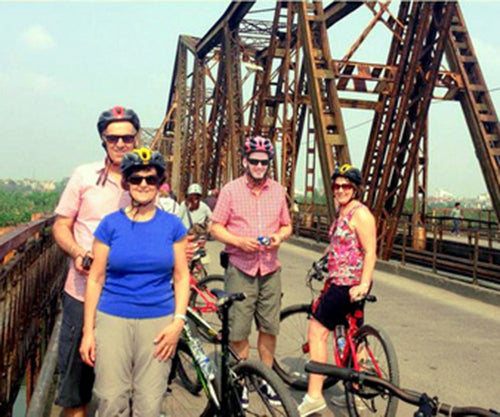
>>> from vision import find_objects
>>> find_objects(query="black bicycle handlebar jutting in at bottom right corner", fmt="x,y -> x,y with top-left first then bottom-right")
306,362 -> 500,417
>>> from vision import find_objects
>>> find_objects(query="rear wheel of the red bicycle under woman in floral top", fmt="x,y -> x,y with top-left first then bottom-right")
345,325 -> 399,417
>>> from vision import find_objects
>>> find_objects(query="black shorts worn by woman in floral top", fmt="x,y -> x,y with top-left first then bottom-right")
313,285 -> 364,330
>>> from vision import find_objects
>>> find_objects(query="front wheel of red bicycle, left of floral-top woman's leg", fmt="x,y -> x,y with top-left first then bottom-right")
273,304 -> 338,391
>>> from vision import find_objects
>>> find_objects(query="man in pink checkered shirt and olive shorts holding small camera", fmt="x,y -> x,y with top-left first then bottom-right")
211,136 -> 292,386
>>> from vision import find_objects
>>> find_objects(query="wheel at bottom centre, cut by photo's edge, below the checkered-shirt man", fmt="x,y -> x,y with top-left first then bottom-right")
231,360 -> 299,417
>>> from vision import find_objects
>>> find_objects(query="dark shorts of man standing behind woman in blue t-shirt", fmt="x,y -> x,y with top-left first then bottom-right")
55,293 -> 94,408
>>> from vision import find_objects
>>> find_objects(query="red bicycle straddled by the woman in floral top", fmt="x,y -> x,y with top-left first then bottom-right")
273,258 -> 399,416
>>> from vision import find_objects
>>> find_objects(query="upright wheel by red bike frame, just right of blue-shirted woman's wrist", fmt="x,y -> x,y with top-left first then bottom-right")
189,274 -> 224,341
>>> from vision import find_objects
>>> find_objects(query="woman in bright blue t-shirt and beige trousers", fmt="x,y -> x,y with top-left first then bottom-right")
80,148 -> 189,417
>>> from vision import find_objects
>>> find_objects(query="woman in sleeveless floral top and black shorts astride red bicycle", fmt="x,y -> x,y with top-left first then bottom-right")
299,164 -> 377,417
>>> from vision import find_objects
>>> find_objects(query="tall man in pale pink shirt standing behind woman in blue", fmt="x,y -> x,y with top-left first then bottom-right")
53,106 -> 140,417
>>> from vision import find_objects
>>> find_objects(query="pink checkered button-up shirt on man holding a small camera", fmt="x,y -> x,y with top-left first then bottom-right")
211,175 -> 290,276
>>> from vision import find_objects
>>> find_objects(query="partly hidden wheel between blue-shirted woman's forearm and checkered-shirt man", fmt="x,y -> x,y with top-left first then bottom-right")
189,274 -> 224,341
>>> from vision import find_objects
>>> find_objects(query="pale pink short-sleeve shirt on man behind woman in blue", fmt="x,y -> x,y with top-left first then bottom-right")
55,161 -> 130,301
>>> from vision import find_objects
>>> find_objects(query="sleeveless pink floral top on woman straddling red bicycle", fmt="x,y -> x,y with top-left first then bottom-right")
328,203 -> 365,286
